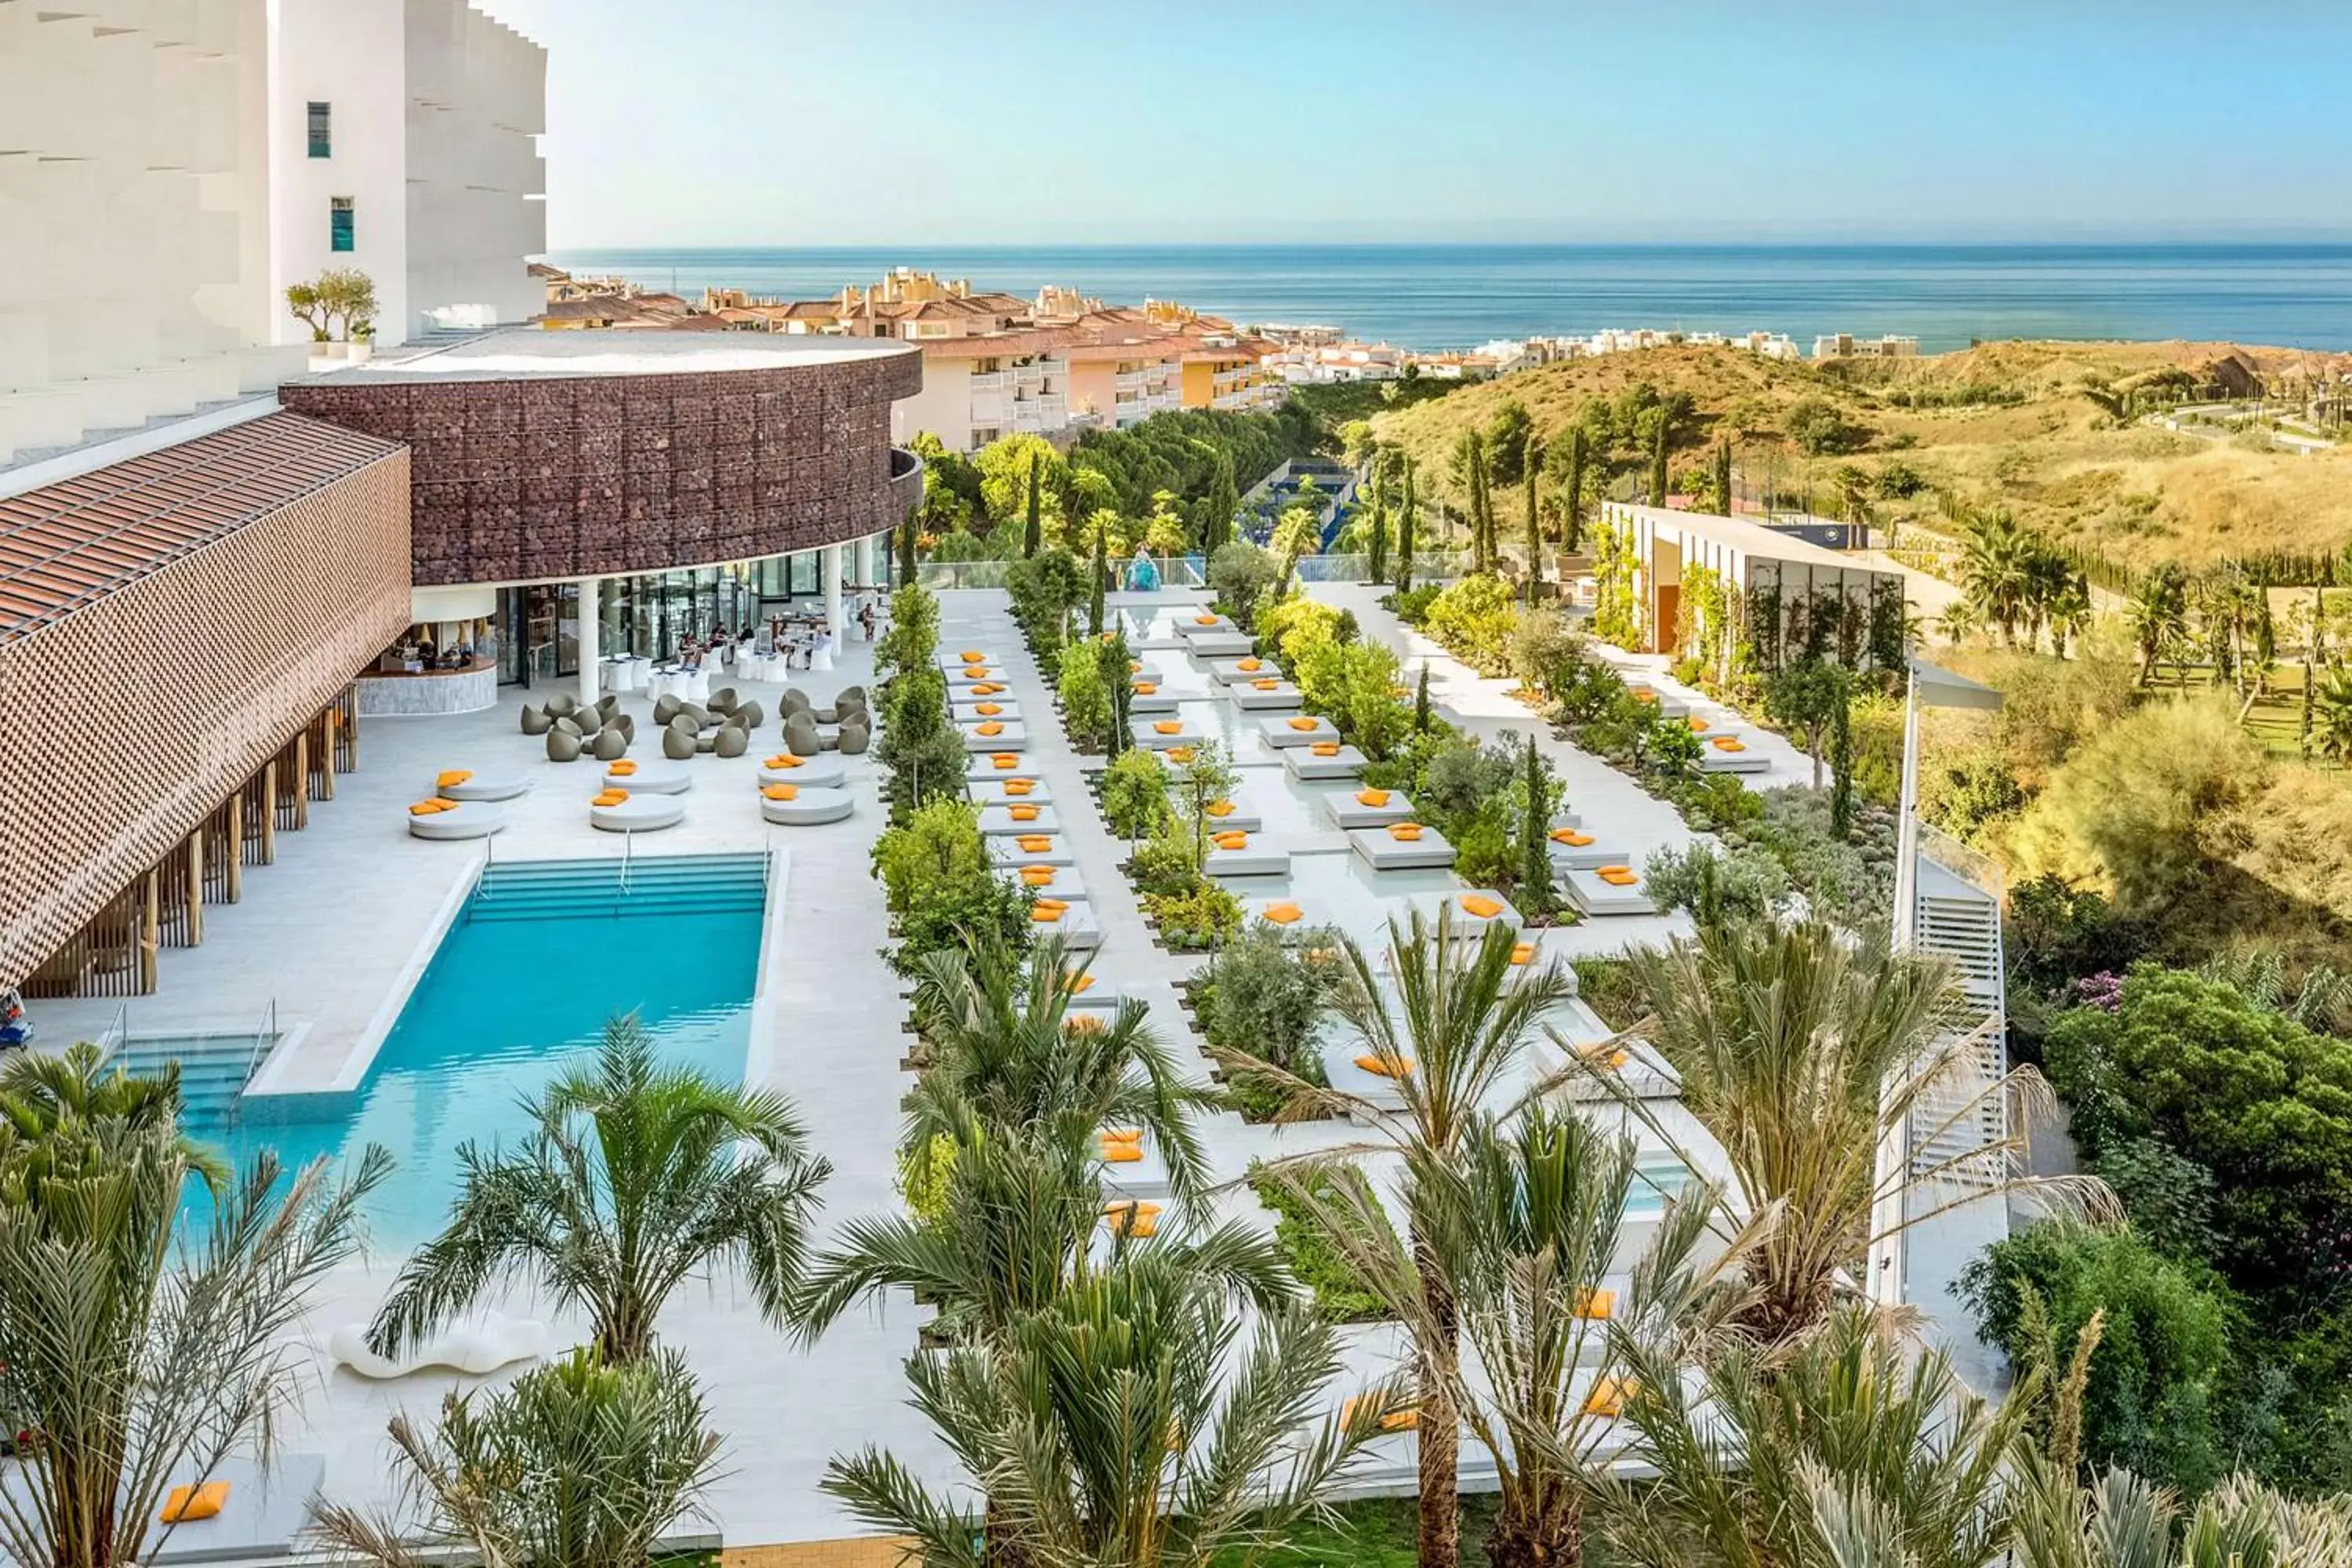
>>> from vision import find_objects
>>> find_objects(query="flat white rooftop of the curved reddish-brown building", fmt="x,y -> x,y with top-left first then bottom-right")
329,327 -> 915,386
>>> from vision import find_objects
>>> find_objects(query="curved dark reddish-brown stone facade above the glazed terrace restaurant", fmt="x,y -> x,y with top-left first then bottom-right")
280,353 -> 922,586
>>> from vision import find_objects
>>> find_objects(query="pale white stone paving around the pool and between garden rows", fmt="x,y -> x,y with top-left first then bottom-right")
9,586 -> 1825,1547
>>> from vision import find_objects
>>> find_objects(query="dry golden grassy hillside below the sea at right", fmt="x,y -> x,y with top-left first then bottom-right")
1374,343 -> 2352,567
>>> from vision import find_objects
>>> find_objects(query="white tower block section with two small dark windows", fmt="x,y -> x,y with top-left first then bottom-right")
268,0 -> 548,346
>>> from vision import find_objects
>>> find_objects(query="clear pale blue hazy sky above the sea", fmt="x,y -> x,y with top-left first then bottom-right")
477,0 -> 2352,249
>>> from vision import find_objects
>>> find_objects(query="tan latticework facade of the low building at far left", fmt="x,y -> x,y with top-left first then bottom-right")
0,416 -> 409,985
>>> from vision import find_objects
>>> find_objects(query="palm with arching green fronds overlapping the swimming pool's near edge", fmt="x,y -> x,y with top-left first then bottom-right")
367,1015 -> 833,1361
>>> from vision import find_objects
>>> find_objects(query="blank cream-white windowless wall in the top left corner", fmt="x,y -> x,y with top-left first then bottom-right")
0,0 -> 299,468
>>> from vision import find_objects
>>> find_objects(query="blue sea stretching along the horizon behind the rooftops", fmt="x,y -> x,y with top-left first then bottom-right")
550,242 -> 2352,353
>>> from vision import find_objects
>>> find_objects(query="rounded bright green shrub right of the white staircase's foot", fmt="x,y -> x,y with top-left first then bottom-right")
1957,1222 -> 2230,1495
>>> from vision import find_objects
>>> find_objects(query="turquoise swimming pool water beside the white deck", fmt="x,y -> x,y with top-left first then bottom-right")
135,855 -> 767,1250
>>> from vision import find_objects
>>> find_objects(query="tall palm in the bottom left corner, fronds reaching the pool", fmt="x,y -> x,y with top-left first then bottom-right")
0,1116 -> 390,1568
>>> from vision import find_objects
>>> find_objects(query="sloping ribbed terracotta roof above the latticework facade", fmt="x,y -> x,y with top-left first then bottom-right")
0,414 -> 400,642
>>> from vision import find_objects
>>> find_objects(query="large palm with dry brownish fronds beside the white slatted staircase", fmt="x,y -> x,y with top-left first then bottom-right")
1599,921 -> 2112,1342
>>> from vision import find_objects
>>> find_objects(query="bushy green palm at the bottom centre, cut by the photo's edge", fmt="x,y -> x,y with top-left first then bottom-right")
823,1248 -> 1402,1568
